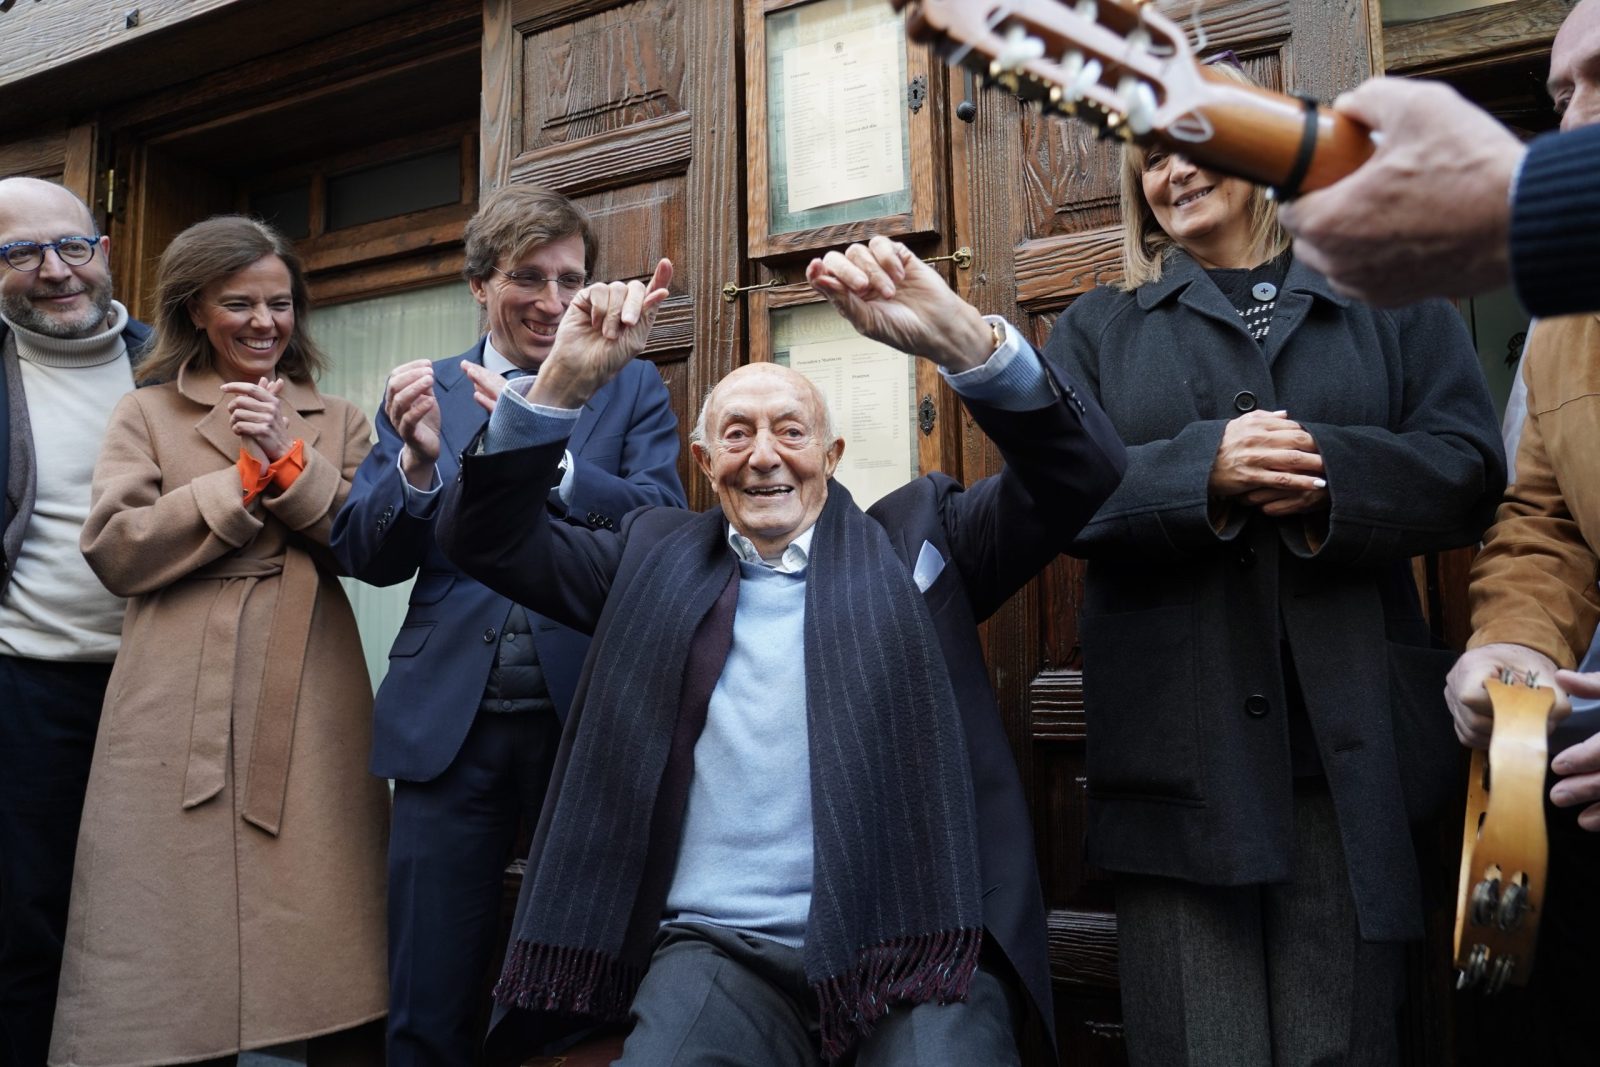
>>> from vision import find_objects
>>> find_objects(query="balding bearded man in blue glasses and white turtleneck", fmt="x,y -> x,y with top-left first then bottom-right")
0,178 -> 149,1067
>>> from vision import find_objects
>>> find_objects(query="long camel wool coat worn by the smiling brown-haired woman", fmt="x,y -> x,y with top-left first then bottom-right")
50,370 -> 389,1067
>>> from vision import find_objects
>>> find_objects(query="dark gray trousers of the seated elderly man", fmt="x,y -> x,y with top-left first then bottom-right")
611,923 -> 1019,1067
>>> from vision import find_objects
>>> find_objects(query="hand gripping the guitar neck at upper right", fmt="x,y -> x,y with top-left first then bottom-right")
1280,78 -> 1523,306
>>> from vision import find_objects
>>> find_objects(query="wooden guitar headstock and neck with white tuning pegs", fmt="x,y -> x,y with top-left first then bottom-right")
891,0 -> 1373,194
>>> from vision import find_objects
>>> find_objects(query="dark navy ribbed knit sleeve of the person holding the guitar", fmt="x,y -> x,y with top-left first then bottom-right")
1510,126 -> 1600,317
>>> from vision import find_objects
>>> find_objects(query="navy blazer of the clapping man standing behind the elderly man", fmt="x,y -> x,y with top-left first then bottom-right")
330,341 -> 686,782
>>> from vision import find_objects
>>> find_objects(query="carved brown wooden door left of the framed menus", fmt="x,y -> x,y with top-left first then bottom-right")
482,0 -> 744,509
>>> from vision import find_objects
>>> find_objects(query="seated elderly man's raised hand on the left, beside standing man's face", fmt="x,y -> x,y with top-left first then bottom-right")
528,259 -> 672,408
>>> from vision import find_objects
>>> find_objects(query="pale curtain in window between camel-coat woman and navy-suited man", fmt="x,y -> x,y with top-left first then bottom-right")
310,282 -> 478,689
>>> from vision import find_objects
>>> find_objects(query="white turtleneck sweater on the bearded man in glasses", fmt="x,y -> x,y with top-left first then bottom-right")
0,301 -> 133,662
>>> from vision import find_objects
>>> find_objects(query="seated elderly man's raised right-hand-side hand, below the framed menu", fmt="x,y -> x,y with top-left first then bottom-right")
805,237 -> 995,374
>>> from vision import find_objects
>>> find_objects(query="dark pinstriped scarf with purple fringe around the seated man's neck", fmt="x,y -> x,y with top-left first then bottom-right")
494,483 -> 982,1061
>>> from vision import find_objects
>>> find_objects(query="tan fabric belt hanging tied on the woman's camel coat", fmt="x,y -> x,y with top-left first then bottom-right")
182,549 -> 317,837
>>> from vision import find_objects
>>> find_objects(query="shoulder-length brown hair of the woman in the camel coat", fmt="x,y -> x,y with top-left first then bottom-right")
133,214 -> 328,382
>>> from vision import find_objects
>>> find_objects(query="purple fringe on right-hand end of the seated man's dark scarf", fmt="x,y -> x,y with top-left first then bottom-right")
811,926 -> 984,1064
